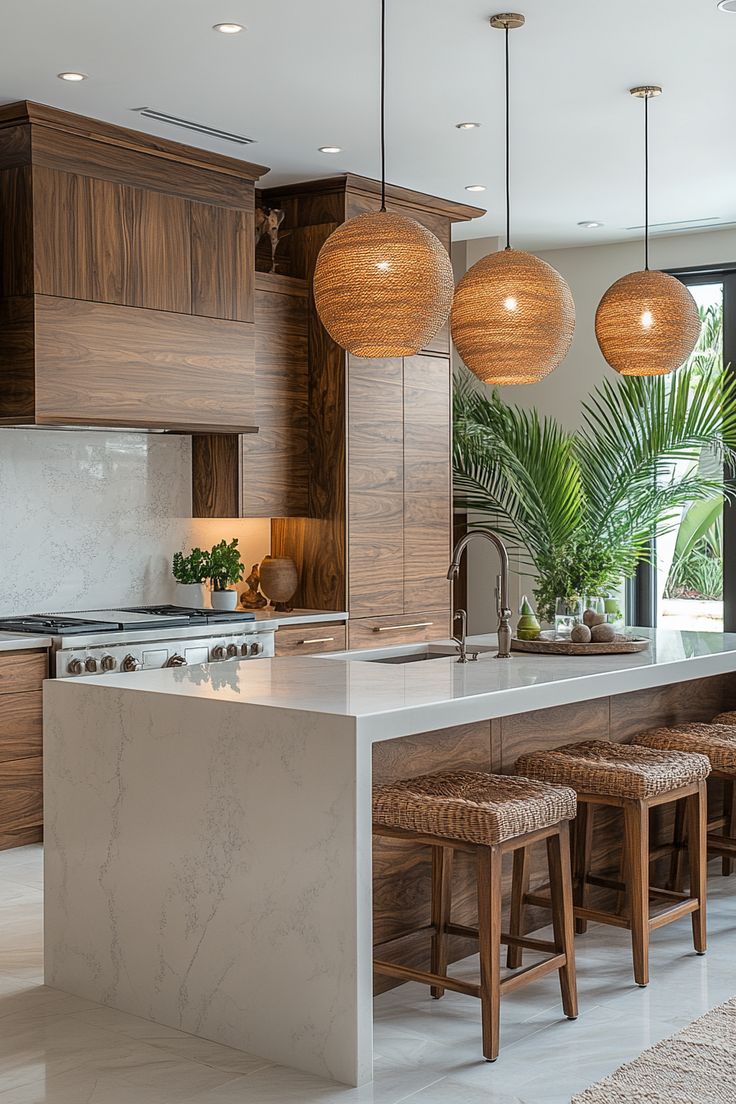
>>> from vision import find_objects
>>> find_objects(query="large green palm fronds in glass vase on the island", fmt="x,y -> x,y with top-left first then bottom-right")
454,364 -> 736,619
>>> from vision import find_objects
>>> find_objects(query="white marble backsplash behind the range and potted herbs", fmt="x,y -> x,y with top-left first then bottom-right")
0,429 -> 270,616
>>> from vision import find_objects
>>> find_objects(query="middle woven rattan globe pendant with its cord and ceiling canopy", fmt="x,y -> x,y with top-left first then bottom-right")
451,12 -> 575,384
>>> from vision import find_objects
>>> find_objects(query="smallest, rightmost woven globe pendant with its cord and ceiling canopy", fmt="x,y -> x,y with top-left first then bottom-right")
596,85 -> 701,375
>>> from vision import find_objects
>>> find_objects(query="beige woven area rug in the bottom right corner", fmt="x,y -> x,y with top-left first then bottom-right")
572,997 -> 736,1104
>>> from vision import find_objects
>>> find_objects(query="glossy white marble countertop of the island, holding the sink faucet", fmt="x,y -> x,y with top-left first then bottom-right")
59,629 -> 736,741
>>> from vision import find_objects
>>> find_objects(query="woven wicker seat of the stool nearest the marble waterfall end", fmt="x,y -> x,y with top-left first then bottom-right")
373,771 -> 577,846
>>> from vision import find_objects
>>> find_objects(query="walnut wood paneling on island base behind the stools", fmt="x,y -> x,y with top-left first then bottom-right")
373,675 -> 736,992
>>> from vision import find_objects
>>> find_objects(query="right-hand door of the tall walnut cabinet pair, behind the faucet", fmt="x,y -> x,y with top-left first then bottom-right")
404,355 -> 452,613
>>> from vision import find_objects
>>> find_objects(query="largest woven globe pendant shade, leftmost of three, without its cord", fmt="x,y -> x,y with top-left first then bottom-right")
313,211 -> 454,357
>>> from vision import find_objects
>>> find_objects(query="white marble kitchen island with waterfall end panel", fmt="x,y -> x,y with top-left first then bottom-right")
44,631 -> 736,1084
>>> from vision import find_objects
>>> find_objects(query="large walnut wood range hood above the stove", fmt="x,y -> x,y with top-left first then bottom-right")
0,102 -> 267,434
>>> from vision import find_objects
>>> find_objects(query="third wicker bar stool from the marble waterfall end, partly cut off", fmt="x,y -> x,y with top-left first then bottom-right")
636,713 -> 736,890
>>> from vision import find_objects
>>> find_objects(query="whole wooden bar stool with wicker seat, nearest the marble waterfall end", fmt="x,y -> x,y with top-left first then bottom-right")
373,771 -> 577,1062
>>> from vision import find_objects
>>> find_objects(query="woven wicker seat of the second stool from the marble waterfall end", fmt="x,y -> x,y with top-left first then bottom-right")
515,740 -> 711,800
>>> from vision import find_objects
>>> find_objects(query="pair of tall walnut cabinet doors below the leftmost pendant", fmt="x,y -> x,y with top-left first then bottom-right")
348,355 -> 451,618
